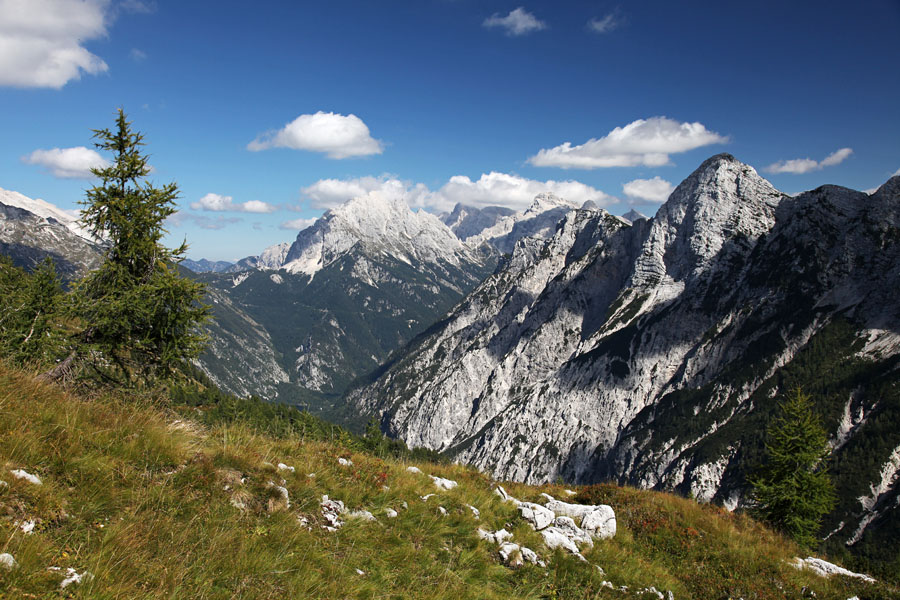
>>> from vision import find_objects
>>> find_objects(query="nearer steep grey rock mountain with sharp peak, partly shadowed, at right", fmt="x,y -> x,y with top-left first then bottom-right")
350,154 -> 900,543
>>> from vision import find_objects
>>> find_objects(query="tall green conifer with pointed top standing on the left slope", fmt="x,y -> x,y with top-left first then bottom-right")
74,109 -> 209,380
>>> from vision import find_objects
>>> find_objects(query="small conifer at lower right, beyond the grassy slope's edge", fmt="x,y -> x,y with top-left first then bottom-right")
751,389 -> 835,547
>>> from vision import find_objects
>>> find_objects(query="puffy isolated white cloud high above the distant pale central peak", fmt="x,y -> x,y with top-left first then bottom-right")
247,111 -> 383,159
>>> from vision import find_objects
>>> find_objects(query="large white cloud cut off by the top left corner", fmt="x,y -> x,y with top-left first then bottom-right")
0,0 -> 109,89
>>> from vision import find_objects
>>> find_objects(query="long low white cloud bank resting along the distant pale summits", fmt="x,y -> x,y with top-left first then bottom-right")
302,172 -> 617,211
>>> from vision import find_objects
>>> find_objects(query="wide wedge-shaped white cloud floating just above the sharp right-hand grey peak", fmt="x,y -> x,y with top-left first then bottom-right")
528,117 -> 728,169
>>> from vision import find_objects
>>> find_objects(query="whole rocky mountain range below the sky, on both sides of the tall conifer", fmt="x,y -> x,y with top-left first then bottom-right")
0,155 -> 900,568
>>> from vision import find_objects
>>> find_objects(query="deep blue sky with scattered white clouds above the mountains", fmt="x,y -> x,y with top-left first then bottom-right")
0,0 -> 900,260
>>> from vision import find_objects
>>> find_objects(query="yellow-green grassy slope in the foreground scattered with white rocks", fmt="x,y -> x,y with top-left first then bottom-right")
0,365 -> 898,600
